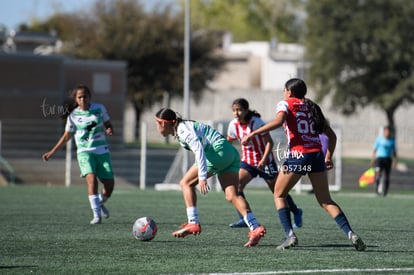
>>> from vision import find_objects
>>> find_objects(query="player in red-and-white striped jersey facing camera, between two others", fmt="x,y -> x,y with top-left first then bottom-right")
227,98 -> 302,228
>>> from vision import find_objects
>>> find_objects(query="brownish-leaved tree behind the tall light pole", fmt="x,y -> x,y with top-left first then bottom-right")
21,0 -> 224,135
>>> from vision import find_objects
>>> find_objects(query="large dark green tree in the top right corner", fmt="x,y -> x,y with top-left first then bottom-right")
306,0 -> 414,131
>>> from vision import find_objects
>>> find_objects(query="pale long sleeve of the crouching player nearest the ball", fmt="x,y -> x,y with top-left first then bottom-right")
177,122 -> 207,180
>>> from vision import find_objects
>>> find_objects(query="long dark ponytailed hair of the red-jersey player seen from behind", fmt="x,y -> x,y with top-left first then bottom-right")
285,78 -> 329,134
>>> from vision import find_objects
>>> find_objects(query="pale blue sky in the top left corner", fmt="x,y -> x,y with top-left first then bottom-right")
0,0 -> 175,31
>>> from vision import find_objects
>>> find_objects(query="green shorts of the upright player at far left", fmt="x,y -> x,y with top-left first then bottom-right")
78,152 -> 114,179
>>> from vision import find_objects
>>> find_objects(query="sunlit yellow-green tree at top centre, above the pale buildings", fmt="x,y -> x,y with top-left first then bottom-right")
190,0 -> 303,42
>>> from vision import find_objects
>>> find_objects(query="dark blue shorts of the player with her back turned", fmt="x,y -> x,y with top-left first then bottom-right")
280,151 -> 326,175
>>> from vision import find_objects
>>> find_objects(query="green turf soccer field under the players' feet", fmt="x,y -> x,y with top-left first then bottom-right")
0,186 -> 414,274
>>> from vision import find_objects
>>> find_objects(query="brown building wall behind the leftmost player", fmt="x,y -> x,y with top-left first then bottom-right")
0,53 -> 127,121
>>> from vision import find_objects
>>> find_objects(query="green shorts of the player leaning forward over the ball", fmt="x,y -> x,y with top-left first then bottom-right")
197,139 -> 240,175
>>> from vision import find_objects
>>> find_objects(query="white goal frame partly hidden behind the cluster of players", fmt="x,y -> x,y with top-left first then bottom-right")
155,124 -> 342,194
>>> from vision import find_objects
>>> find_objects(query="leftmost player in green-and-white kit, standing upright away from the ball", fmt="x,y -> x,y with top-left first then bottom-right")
42,85 -> 115,224
